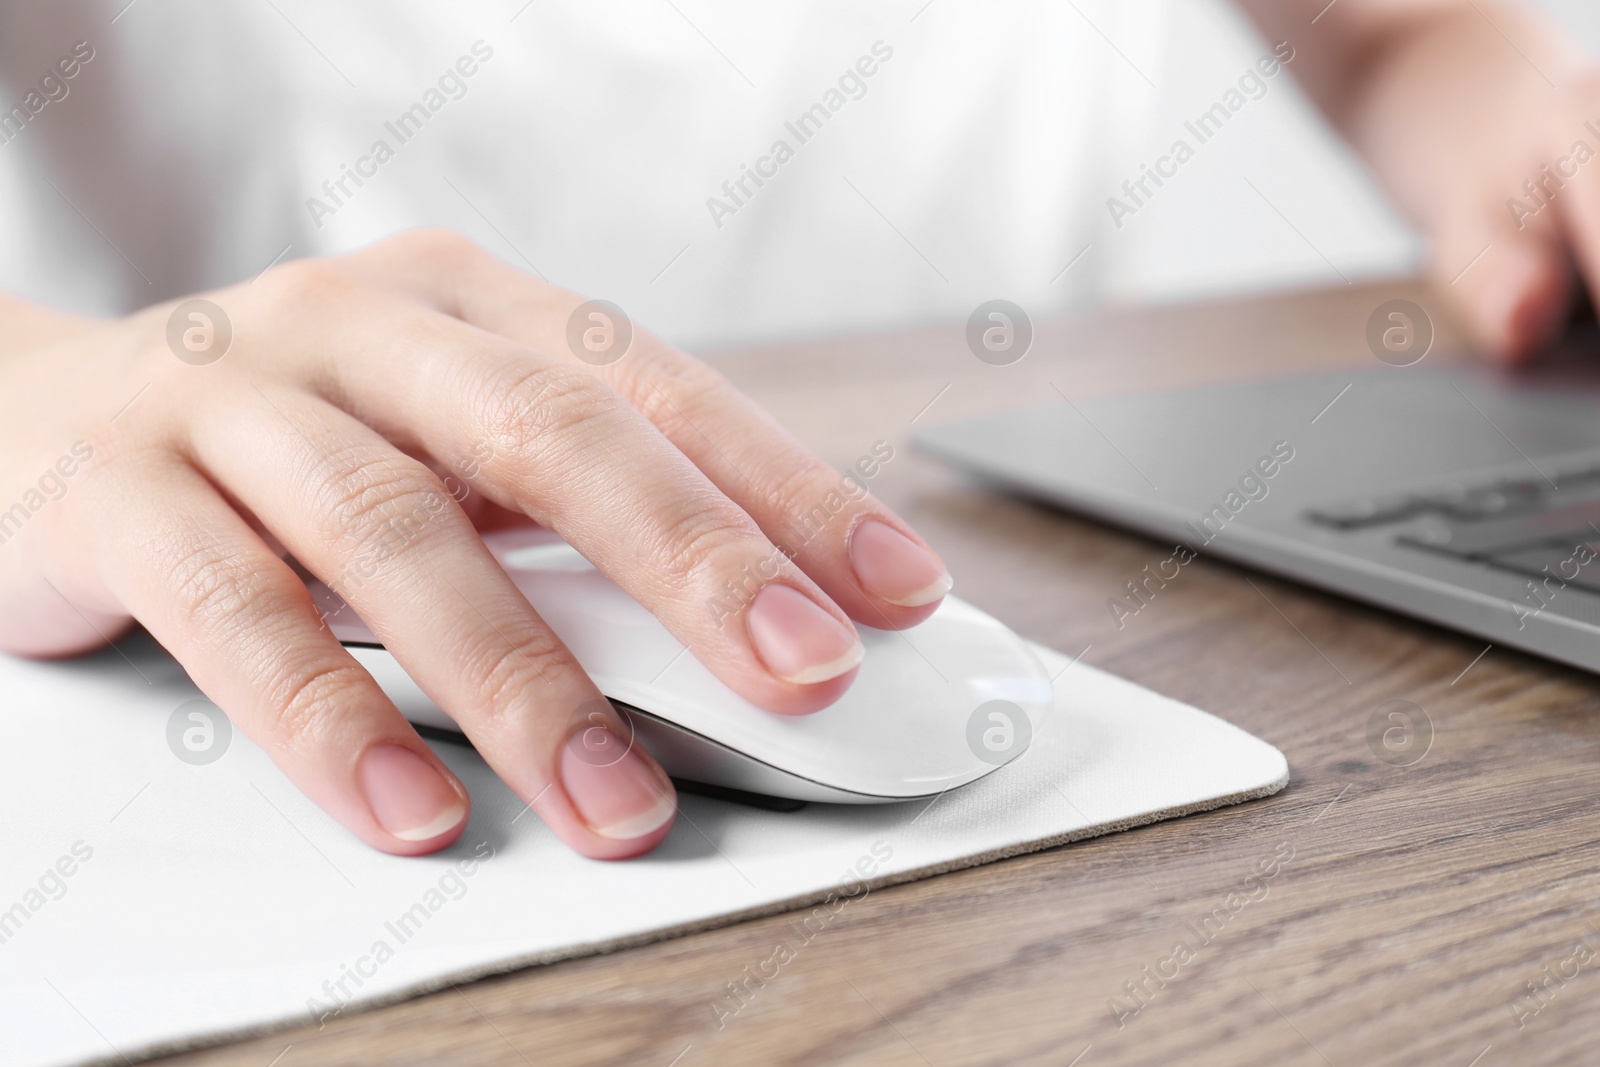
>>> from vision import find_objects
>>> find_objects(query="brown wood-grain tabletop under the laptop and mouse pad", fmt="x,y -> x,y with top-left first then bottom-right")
173,286 -> 1600,1067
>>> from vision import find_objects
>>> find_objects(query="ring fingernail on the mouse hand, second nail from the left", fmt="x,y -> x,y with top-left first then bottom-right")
562,725 -> 678,841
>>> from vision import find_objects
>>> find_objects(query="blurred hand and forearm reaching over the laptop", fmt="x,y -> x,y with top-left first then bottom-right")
1243,0 -> 1600,360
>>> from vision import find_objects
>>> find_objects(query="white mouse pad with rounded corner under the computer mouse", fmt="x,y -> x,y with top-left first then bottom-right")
0,638 -> 1288,1065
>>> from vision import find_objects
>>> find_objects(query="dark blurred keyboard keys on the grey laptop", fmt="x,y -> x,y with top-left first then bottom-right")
1306,466 -> 1600,592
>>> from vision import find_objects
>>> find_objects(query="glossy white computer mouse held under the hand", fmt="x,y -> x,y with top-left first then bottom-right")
310,530 -> 1054,803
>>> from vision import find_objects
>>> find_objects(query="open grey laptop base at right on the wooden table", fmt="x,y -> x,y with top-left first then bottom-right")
914,339 -> 1600,670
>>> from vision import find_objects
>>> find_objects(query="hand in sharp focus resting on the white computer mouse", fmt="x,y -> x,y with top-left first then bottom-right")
0,232 -> 950,859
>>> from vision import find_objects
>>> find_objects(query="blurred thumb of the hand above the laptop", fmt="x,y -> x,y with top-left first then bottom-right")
1434,202 -> 1573,363
